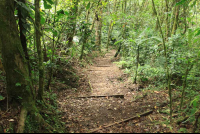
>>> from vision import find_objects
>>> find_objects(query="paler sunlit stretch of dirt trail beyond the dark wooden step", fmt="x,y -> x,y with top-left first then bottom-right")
88,50 -> 127,95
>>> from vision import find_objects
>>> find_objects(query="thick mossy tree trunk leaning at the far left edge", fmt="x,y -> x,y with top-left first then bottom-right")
0,0 -> 34,106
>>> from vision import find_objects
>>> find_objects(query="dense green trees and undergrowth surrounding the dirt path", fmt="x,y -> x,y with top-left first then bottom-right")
0,0 -> 200,132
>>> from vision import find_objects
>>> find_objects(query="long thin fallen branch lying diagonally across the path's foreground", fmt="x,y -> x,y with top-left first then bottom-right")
89,110 -> 153,133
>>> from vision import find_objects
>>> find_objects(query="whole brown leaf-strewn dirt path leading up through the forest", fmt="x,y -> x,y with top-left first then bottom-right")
58,50 -> 170,133
